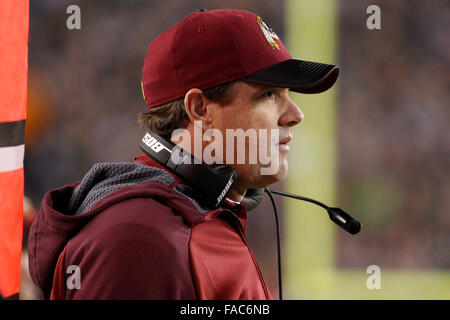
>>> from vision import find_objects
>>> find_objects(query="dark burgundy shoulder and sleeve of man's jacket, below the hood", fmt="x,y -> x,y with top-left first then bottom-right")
64,198 -> 196,299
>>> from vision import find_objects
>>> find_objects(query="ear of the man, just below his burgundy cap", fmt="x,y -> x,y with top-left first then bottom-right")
184,88 -> 212,129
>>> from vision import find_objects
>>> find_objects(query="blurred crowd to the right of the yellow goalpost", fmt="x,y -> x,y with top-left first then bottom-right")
337,0 -> 450,269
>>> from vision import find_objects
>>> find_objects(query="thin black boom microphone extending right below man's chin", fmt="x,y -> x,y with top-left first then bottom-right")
266,188 -> 361,234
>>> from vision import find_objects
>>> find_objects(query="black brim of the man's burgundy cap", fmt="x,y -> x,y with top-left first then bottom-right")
242,59 -> 339,93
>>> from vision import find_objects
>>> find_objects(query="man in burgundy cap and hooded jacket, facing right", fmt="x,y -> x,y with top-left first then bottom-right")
29,10 -> 338,299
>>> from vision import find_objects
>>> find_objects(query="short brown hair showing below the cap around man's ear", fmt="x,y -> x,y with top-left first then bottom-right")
137,81 -> 235,136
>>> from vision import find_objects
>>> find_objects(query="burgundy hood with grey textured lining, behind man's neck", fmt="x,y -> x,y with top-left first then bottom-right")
28,155 -> 229,296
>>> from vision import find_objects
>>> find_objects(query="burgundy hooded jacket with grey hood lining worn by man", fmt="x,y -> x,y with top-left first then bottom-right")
28,155 -> 271,300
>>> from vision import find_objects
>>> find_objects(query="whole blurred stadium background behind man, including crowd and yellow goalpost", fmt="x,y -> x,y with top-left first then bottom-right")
16,0 -> 450,299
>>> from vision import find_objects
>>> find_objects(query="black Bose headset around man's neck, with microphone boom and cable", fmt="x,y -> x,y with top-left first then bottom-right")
139,131 -> 361,300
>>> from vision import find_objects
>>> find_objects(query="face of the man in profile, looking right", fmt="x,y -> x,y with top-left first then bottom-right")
208,81 -> 304,189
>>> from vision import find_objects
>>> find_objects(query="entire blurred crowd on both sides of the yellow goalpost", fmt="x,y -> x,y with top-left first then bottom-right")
24,0 -> 450,298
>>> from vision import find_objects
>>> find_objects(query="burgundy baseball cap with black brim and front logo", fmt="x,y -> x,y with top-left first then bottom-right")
142,9 -> 339,108
